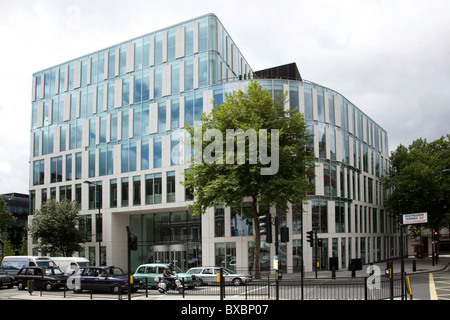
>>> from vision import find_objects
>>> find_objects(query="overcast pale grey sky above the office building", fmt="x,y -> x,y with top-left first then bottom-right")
0,0 -> 450,194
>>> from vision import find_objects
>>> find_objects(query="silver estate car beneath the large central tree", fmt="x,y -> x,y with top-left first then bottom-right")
187,267 -> 252,286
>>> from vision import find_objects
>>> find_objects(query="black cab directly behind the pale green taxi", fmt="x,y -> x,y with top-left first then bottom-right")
69,266 -> 141,294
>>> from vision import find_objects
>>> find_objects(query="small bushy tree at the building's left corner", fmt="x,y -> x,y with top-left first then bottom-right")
30,199 -> 86,257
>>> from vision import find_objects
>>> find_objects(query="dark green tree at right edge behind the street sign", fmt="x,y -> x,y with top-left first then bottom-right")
383,134 -> 450,230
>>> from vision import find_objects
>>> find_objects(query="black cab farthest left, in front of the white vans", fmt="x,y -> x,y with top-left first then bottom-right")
14,267 -> 67,290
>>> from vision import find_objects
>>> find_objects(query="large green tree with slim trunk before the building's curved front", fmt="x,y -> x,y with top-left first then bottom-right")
183,81 -> 314,278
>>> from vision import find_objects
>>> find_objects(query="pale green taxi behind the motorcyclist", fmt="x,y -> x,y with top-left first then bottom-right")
134,263 -> 196,288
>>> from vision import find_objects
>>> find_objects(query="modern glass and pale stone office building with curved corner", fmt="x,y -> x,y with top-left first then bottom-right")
29,14 -> 398,272
